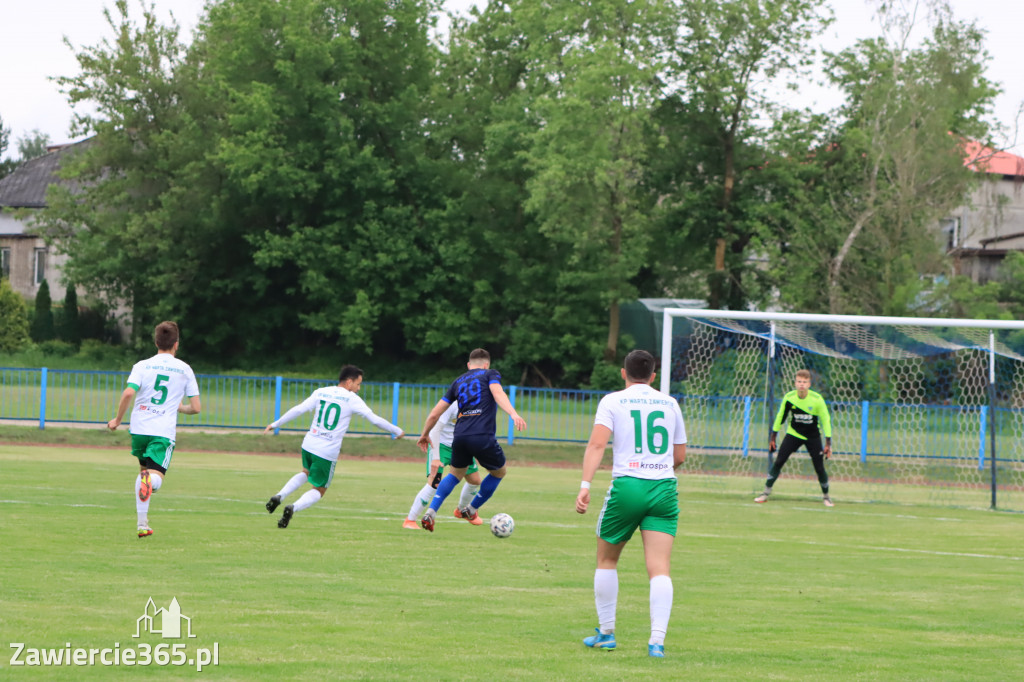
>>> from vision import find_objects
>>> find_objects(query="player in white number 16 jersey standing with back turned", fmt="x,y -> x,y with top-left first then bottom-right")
577,350 -> 686,658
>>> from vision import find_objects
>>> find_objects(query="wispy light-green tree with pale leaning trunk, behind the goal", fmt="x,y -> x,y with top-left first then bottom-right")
823,0 -> 998,314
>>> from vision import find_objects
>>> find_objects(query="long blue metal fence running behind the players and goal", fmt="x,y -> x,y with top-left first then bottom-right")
0,368 -> 1021,462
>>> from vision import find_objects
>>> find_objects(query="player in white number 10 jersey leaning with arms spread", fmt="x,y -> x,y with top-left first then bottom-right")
263,365 -> 404,528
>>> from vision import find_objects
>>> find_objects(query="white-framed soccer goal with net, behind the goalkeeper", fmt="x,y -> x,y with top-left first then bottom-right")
660,308 -> 1024,511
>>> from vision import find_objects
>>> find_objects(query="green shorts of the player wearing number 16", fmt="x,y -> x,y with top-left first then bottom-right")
597,476 -> 679,545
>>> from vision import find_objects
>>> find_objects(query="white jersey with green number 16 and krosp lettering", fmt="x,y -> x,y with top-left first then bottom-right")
594,384 -> 686,480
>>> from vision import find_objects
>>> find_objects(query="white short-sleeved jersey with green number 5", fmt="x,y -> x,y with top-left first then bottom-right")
128,353 -> 199,440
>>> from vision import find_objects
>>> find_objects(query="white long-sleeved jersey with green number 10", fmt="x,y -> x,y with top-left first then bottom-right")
270,386 -> 402,462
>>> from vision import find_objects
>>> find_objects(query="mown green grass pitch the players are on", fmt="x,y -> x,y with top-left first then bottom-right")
0,445 -> 1024,681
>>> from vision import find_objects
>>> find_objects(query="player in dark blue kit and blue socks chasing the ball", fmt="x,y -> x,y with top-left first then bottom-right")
417,348 -> 526,532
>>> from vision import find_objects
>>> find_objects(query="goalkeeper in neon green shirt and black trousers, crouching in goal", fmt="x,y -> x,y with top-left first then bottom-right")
754,370 -> 833,507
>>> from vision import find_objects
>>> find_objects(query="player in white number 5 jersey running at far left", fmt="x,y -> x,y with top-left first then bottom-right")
106,322 -> 201,538
